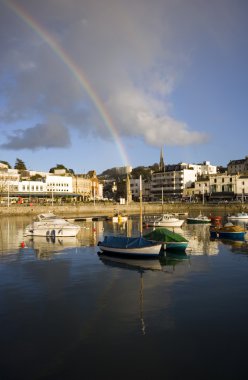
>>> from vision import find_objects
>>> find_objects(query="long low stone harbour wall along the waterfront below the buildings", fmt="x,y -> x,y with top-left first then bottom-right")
0,202 -> 245,217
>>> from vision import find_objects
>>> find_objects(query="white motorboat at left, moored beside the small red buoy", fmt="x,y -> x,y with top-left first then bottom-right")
24,212 -> 81,237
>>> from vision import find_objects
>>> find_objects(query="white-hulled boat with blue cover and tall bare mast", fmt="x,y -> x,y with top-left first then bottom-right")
98,176 -> 162,258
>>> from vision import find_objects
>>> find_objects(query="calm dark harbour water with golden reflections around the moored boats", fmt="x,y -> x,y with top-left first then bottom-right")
0,218 -> 248,380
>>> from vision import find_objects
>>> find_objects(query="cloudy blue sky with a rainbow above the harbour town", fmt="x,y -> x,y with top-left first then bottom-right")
0,0 -> 248,174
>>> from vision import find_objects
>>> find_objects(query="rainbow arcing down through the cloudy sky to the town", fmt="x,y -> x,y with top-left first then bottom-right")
5,1 -> 129,166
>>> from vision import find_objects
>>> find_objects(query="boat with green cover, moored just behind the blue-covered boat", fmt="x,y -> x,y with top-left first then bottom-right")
144,228 -> 189,251
